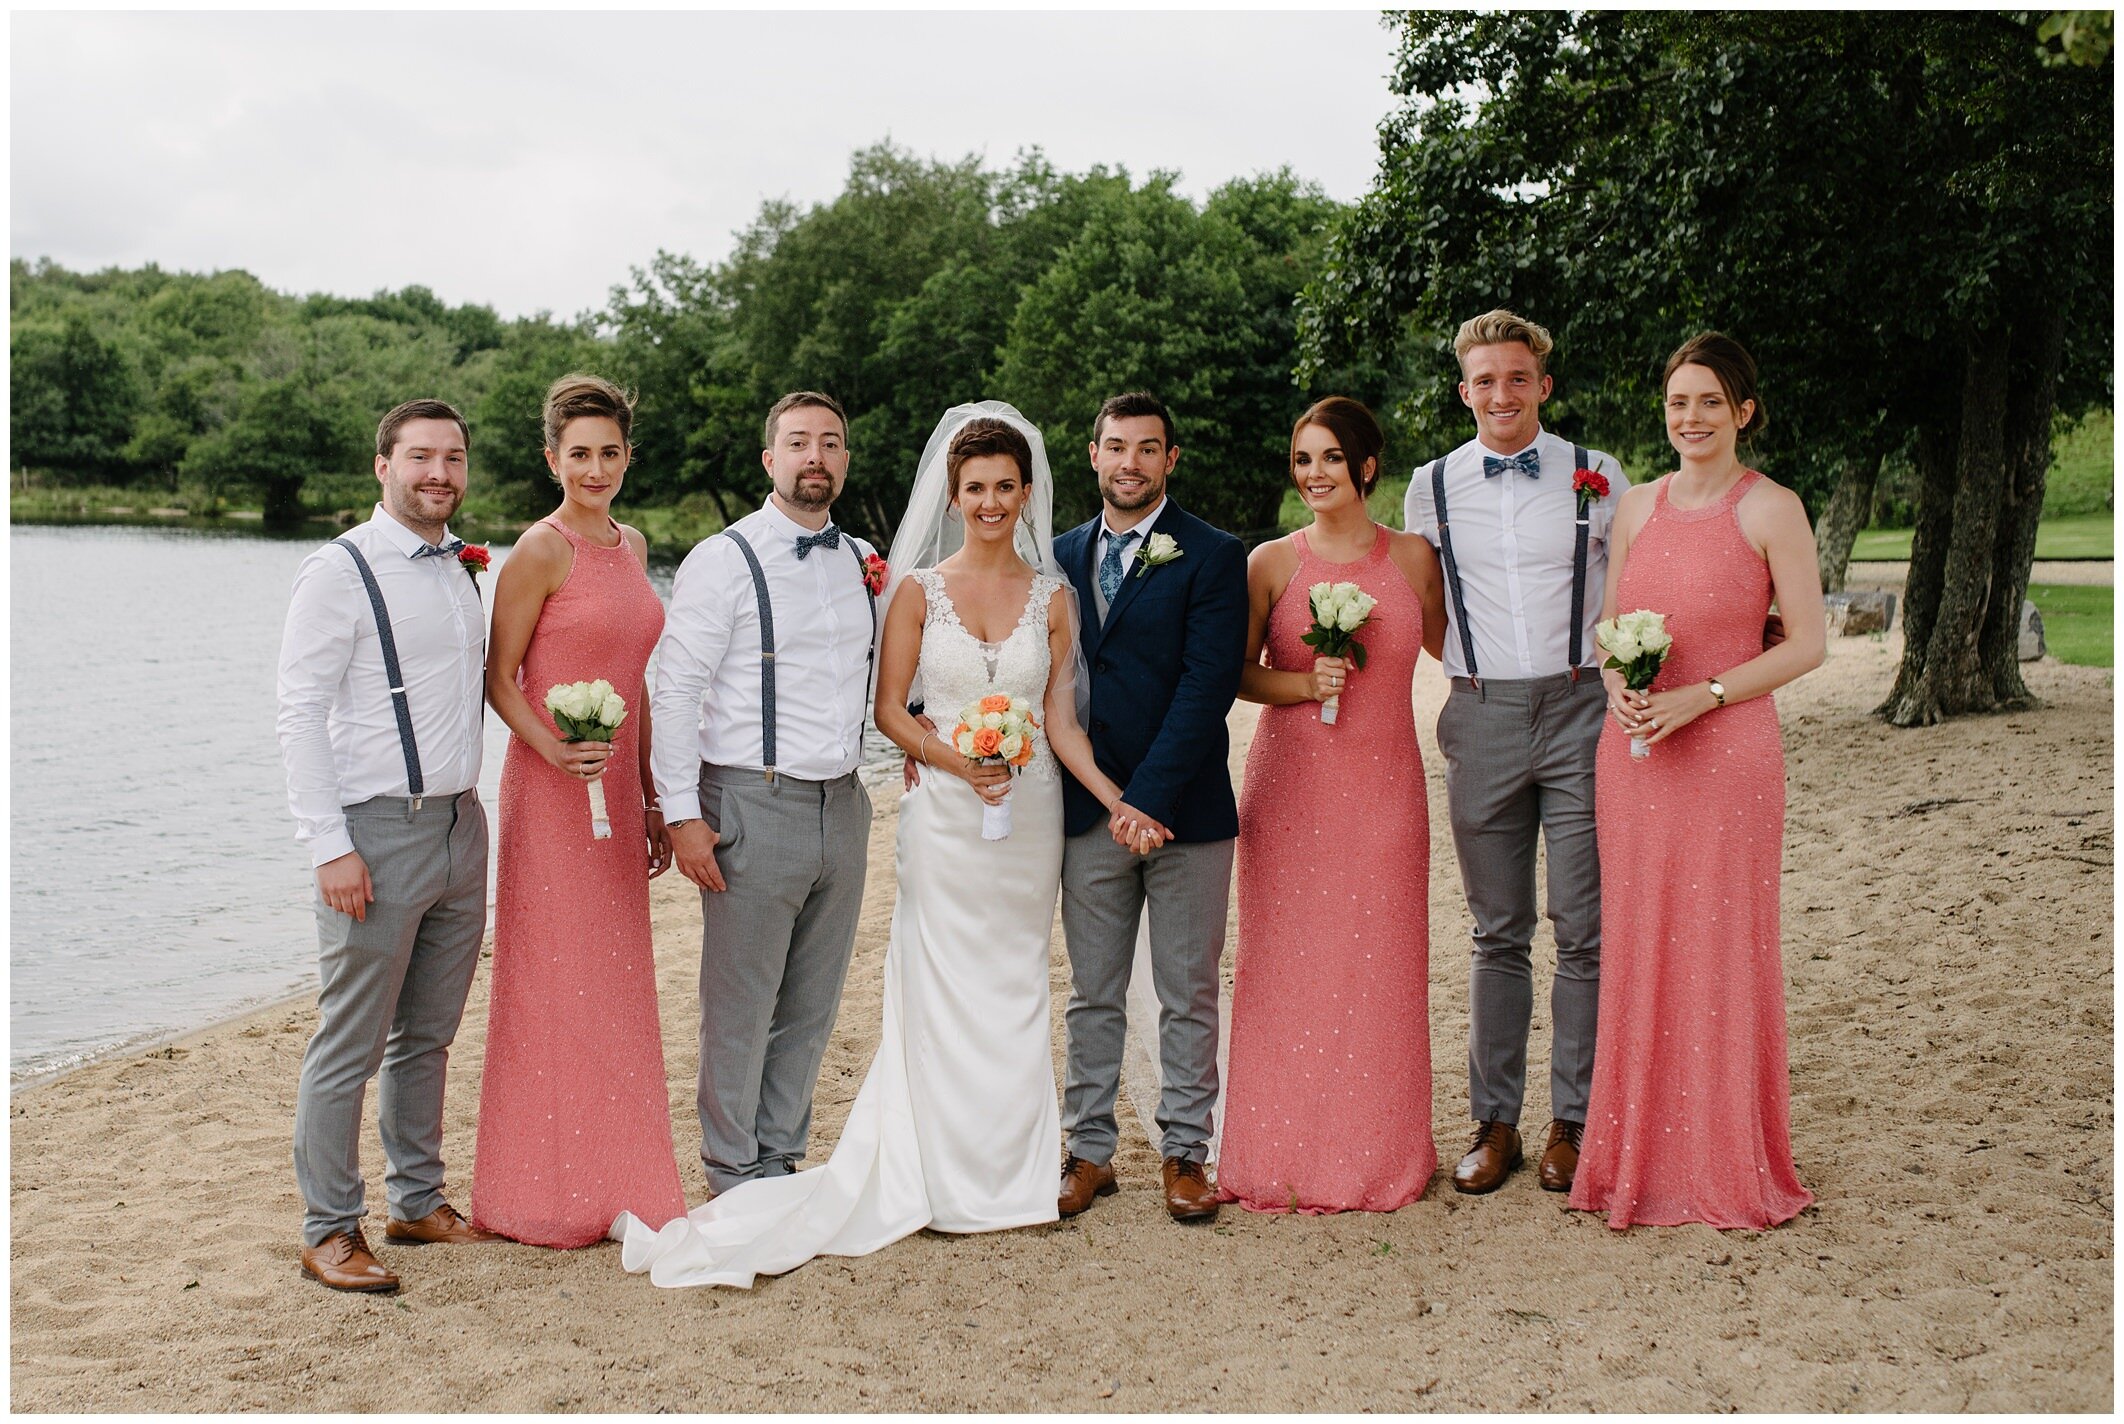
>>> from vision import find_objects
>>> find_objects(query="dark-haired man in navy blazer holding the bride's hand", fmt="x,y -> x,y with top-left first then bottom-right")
1056,391 -> 1247,1220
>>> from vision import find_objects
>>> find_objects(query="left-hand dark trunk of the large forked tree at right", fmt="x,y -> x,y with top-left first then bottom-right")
1888,323 -> 2011,727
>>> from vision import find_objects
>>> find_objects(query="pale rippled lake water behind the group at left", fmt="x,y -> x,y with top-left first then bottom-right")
8,527 -> 896,1082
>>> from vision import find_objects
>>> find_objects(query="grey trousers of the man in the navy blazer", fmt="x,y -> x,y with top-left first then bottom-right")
1062,825 -> 1236,1163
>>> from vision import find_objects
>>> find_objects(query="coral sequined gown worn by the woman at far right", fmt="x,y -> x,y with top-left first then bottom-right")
1572,472 -> 1814,1228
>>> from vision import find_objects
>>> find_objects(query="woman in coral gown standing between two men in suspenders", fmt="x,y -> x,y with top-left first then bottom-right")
472,376 -> 686,1245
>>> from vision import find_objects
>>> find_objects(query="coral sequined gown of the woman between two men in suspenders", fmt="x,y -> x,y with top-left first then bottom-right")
472,519 -> 686,1245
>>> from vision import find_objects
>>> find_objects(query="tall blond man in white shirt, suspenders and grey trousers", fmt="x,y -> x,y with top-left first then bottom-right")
1406,310 -> 1625,1192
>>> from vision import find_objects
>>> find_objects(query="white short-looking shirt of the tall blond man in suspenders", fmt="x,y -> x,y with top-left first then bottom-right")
1404,429 -> 1627,678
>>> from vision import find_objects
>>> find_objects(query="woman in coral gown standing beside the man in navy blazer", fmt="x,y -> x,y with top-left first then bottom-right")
1217,395 -> 1446,1211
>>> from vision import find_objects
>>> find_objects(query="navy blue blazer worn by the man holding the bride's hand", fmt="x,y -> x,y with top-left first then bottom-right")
1056,497 -> 1247,842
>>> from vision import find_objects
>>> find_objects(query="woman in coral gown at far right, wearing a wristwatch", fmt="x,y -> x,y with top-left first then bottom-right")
1572,332 -> 1825,1228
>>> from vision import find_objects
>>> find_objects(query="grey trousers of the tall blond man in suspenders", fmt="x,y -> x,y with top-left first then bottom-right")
1438,672 -> 1608,1124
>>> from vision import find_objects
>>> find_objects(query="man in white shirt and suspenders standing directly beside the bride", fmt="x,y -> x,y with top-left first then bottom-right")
650,391 -> 877,1192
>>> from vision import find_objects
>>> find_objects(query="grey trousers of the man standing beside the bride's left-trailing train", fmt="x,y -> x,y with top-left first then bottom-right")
697,765 -> 871,1192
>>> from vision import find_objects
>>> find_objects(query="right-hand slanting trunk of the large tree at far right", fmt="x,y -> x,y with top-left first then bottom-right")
1977,306 -> 2065,710
